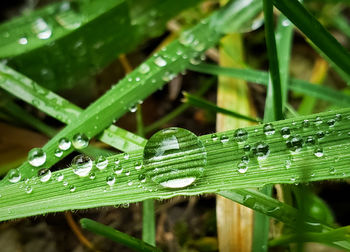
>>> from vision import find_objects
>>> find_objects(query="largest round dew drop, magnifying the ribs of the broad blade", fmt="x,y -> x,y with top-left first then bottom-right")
143,127 -> 207,188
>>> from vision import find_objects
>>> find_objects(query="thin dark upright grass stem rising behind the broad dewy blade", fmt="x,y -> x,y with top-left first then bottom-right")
263,0 -> 283,122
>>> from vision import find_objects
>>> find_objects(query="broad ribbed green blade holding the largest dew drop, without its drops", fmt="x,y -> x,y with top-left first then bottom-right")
0,109 -> 350,220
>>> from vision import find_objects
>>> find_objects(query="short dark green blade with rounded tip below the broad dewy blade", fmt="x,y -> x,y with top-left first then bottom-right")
80,218 -> 161,252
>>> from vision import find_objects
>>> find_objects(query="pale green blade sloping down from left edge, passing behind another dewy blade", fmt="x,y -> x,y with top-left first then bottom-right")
0,65 -> 146,151
